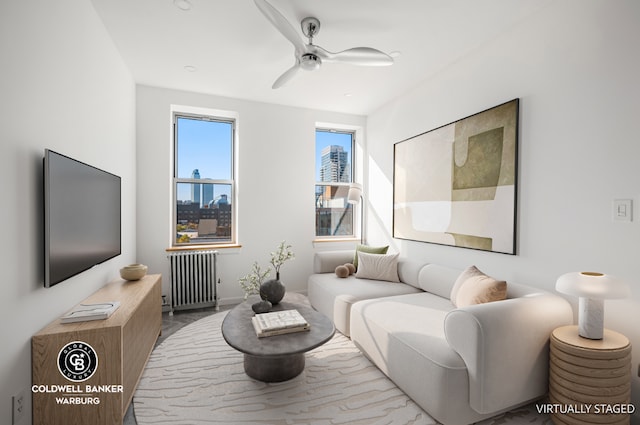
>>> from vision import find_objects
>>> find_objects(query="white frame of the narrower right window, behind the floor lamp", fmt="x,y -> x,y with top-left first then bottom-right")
314,124 -> 362,241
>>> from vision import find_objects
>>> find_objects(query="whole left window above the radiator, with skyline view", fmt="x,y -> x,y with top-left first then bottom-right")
173,114 -> 235,246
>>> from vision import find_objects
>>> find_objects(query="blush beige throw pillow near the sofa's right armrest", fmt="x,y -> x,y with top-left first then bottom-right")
451,266 -> 507,307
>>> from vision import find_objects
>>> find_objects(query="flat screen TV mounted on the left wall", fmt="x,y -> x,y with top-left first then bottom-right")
44,149 -> 122,288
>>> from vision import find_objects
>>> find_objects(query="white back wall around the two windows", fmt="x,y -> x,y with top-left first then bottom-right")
137,86 -> 365,303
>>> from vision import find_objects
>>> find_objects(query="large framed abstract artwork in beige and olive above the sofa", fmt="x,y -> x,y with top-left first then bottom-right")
393,99 -> 519,255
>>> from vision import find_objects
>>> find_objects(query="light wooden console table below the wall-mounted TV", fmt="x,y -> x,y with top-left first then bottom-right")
31,274 -> 162,425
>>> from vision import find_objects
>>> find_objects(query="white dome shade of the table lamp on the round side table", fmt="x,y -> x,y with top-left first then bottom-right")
556,272 -> 630,300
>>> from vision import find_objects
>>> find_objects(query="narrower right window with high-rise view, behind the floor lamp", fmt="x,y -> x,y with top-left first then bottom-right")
315,129 -> 355,238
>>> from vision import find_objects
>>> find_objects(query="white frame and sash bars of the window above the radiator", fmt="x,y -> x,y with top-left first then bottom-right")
170,109 -> 238,250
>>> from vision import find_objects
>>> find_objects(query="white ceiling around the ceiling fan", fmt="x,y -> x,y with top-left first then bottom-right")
91,0 -> 547,115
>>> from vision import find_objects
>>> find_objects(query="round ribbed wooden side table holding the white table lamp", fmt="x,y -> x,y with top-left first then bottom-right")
549,326 -> 631,425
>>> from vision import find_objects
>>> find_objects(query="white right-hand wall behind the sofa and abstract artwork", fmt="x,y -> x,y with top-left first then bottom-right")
366,0 -> 640,420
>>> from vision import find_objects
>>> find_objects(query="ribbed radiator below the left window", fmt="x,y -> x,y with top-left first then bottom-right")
169,251 -> 218,313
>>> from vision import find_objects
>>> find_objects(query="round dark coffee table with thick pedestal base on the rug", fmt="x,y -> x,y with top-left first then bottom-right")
222,293 -> 335,382
